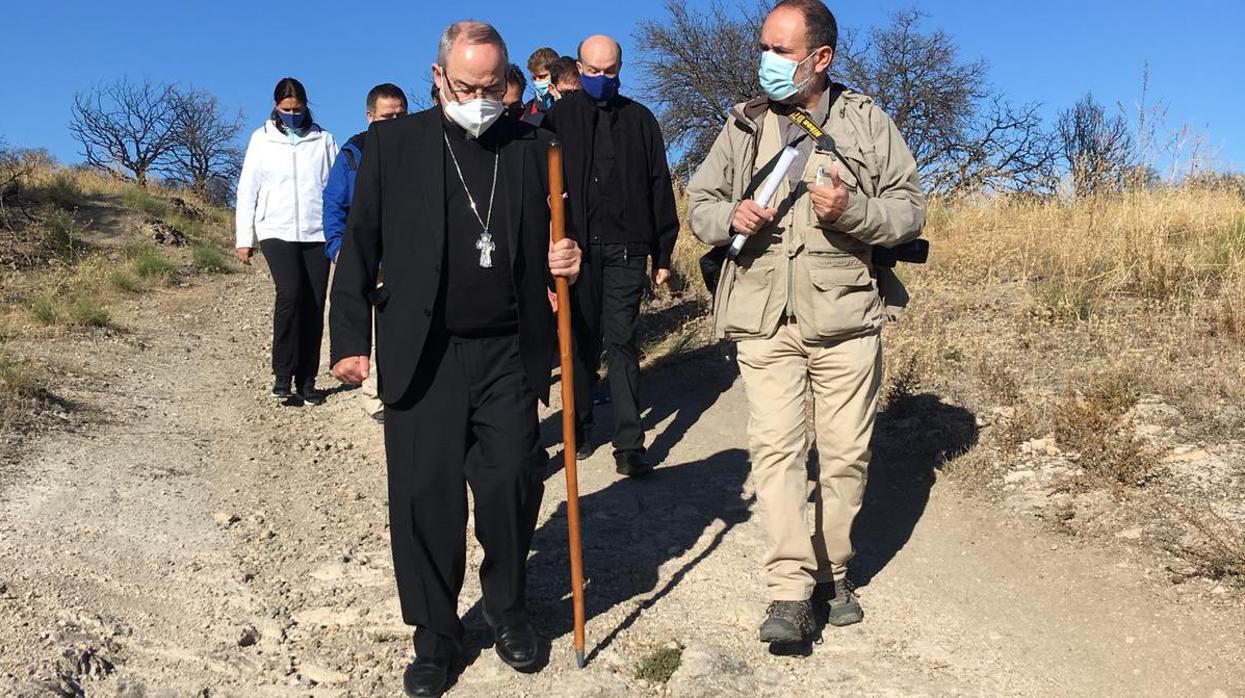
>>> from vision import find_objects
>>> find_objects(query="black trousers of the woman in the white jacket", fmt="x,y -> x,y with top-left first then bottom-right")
259,240 -> 329,387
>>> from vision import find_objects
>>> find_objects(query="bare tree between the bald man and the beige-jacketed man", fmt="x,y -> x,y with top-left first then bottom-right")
635,0 -> 768,174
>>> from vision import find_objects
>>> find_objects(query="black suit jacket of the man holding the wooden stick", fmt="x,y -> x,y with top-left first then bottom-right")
329,107 -> 554,404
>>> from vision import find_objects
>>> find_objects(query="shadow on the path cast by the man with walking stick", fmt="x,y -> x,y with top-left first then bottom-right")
463,449 -> 751,663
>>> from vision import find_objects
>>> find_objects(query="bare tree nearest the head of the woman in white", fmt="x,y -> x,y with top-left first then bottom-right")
156,87 -> 244,198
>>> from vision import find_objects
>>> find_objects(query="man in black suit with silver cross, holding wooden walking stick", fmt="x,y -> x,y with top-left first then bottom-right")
330,21 -> 580,696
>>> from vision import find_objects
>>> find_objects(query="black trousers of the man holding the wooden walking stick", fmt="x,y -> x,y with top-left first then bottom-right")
385,333 -> 545,657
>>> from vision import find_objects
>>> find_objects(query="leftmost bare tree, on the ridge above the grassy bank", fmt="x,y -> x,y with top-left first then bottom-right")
70,78 -> 174,187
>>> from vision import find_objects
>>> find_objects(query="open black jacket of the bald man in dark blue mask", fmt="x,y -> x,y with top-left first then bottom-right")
542,90 -> 679,269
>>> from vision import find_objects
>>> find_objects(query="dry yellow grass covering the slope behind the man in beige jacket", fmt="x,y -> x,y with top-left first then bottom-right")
674,180 -> 1245,576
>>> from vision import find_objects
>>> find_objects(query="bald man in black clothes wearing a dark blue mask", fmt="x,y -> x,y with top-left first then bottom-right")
545,35 -> 679,478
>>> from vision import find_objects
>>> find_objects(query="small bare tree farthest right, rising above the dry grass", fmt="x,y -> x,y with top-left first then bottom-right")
1057,95 -> 1135,197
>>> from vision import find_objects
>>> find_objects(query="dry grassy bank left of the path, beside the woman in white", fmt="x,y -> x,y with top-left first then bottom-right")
0,162 -> 232,328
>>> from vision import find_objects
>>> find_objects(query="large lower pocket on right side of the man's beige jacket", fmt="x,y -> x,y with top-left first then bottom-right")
797,260 -> 881,340
